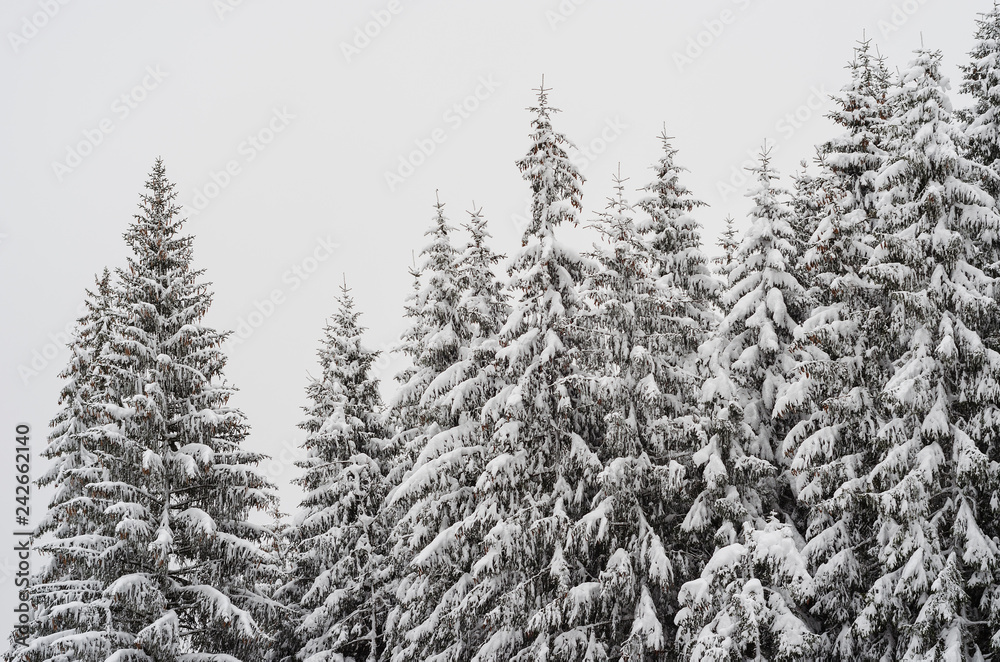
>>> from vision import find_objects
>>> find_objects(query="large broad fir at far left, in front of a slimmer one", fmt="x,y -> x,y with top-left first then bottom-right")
14,160 -> 282,662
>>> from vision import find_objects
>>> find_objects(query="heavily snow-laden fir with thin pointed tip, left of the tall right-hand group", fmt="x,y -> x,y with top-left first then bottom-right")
675,151 -> 815,659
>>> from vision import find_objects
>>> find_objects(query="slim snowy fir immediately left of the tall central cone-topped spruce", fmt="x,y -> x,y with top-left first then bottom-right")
380,205 -> 509,660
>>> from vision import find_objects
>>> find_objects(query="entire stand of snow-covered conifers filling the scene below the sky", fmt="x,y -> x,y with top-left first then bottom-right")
15,8 -> 1000,662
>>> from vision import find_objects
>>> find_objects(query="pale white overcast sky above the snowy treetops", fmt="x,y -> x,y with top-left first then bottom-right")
0,0 -> 991,634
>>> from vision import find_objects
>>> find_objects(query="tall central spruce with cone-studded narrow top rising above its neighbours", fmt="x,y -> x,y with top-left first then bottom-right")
454,80 -> 600,661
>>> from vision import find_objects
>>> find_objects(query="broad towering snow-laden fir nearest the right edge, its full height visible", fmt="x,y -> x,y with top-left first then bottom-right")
854,49 -> 1000,659
